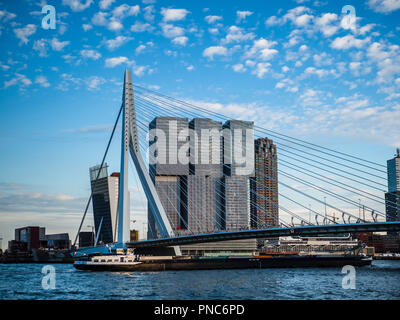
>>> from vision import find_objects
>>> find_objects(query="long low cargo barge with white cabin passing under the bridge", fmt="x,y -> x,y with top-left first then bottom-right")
74,255 -> 372,272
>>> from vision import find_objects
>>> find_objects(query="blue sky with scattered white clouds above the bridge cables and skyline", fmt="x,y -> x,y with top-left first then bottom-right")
0,0 -> 400,247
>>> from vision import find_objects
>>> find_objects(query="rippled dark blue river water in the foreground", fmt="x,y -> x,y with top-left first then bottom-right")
0,261 -> 400,300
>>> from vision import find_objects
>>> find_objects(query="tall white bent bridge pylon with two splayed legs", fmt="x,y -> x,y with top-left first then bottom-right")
117,70 -> 180,255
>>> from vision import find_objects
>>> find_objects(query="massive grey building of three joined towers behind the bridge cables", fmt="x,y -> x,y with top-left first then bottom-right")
148,117 -> 254,239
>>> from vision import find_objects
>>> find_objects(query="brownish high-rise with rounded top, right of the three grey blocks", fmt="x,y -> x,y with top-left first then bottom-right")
250,138 -> 279,229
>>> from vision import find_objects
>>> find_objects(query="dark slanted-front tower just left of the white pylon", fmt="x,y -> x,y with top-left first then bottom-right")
89,164 -> 119,243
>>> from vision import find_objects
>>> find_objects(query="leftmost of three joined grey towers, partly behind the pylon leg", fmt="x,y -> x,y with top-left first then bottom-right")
147,117 -> 189,239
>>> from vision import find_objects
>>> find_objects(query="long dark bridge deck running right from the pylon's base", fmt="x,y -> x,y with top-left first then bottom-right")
126,221 -> 400,248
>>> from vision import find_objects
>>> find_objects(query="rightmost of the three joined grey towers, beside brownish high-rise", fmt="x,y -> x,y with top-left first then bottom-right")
217,120 -> 254,230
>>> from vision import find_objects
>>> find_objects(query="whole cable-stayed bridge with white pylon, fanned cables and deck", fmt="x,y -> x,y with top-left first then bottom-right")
74,70 -> 400,254
